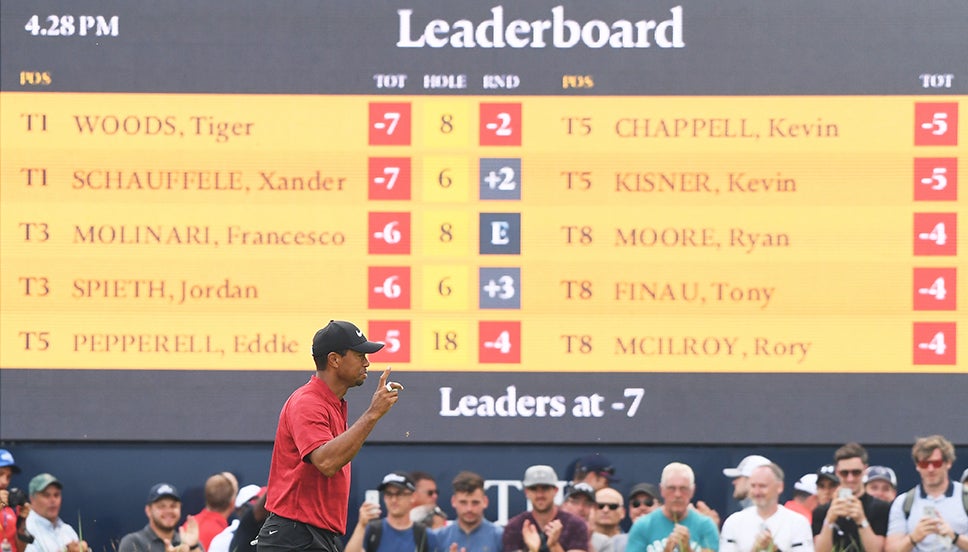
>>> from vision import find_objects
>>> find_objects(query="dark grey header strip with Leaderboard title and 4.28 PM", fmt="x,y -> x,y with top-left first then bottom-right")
0,0 -> 968,96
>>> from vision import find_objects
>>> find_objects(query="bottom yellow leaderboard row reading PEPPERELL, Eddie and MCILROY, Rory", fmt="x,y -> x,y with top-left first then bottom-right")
0,312 -> 966,373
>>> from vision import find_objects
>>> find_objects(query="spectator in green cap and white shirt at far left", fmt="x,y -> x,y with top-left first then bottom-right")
25,473 -> 88,552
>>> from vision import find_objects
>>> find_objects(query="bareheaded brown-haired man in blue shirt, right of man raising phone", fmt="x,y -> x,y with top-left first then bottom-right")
435,471 -> 504,552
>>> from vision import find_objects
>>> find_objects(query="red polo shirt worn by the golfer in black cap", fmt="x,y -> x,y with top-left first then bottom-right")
266,375 -> 350,535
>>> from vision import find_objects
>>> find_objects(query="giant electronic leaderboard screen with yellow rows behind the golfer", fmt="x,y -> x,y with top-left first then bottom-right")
0,0 -> 968,443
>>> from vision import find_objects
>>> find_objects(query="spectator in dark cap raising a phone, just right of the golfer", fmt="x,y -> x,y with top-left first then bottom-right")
345,472 -> 437,552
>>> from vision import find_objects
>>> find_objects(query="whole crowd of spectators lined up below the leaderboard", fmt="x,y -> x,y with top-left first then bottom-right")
0,435 -> 968,552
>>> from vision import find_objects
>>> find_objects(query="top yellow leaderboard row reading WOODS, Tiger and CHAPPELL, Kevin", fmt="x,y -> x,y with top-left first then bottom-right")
0,92 -> 965,154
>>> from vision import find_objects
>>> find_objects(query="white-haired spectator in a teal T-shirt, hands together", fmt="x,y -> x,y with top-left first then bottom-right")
626,462 -> 719,552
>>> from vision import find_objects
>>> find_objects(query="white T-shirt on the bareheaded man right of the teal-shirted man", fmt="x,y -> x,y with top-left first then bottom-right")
719,505 -> 813,552
